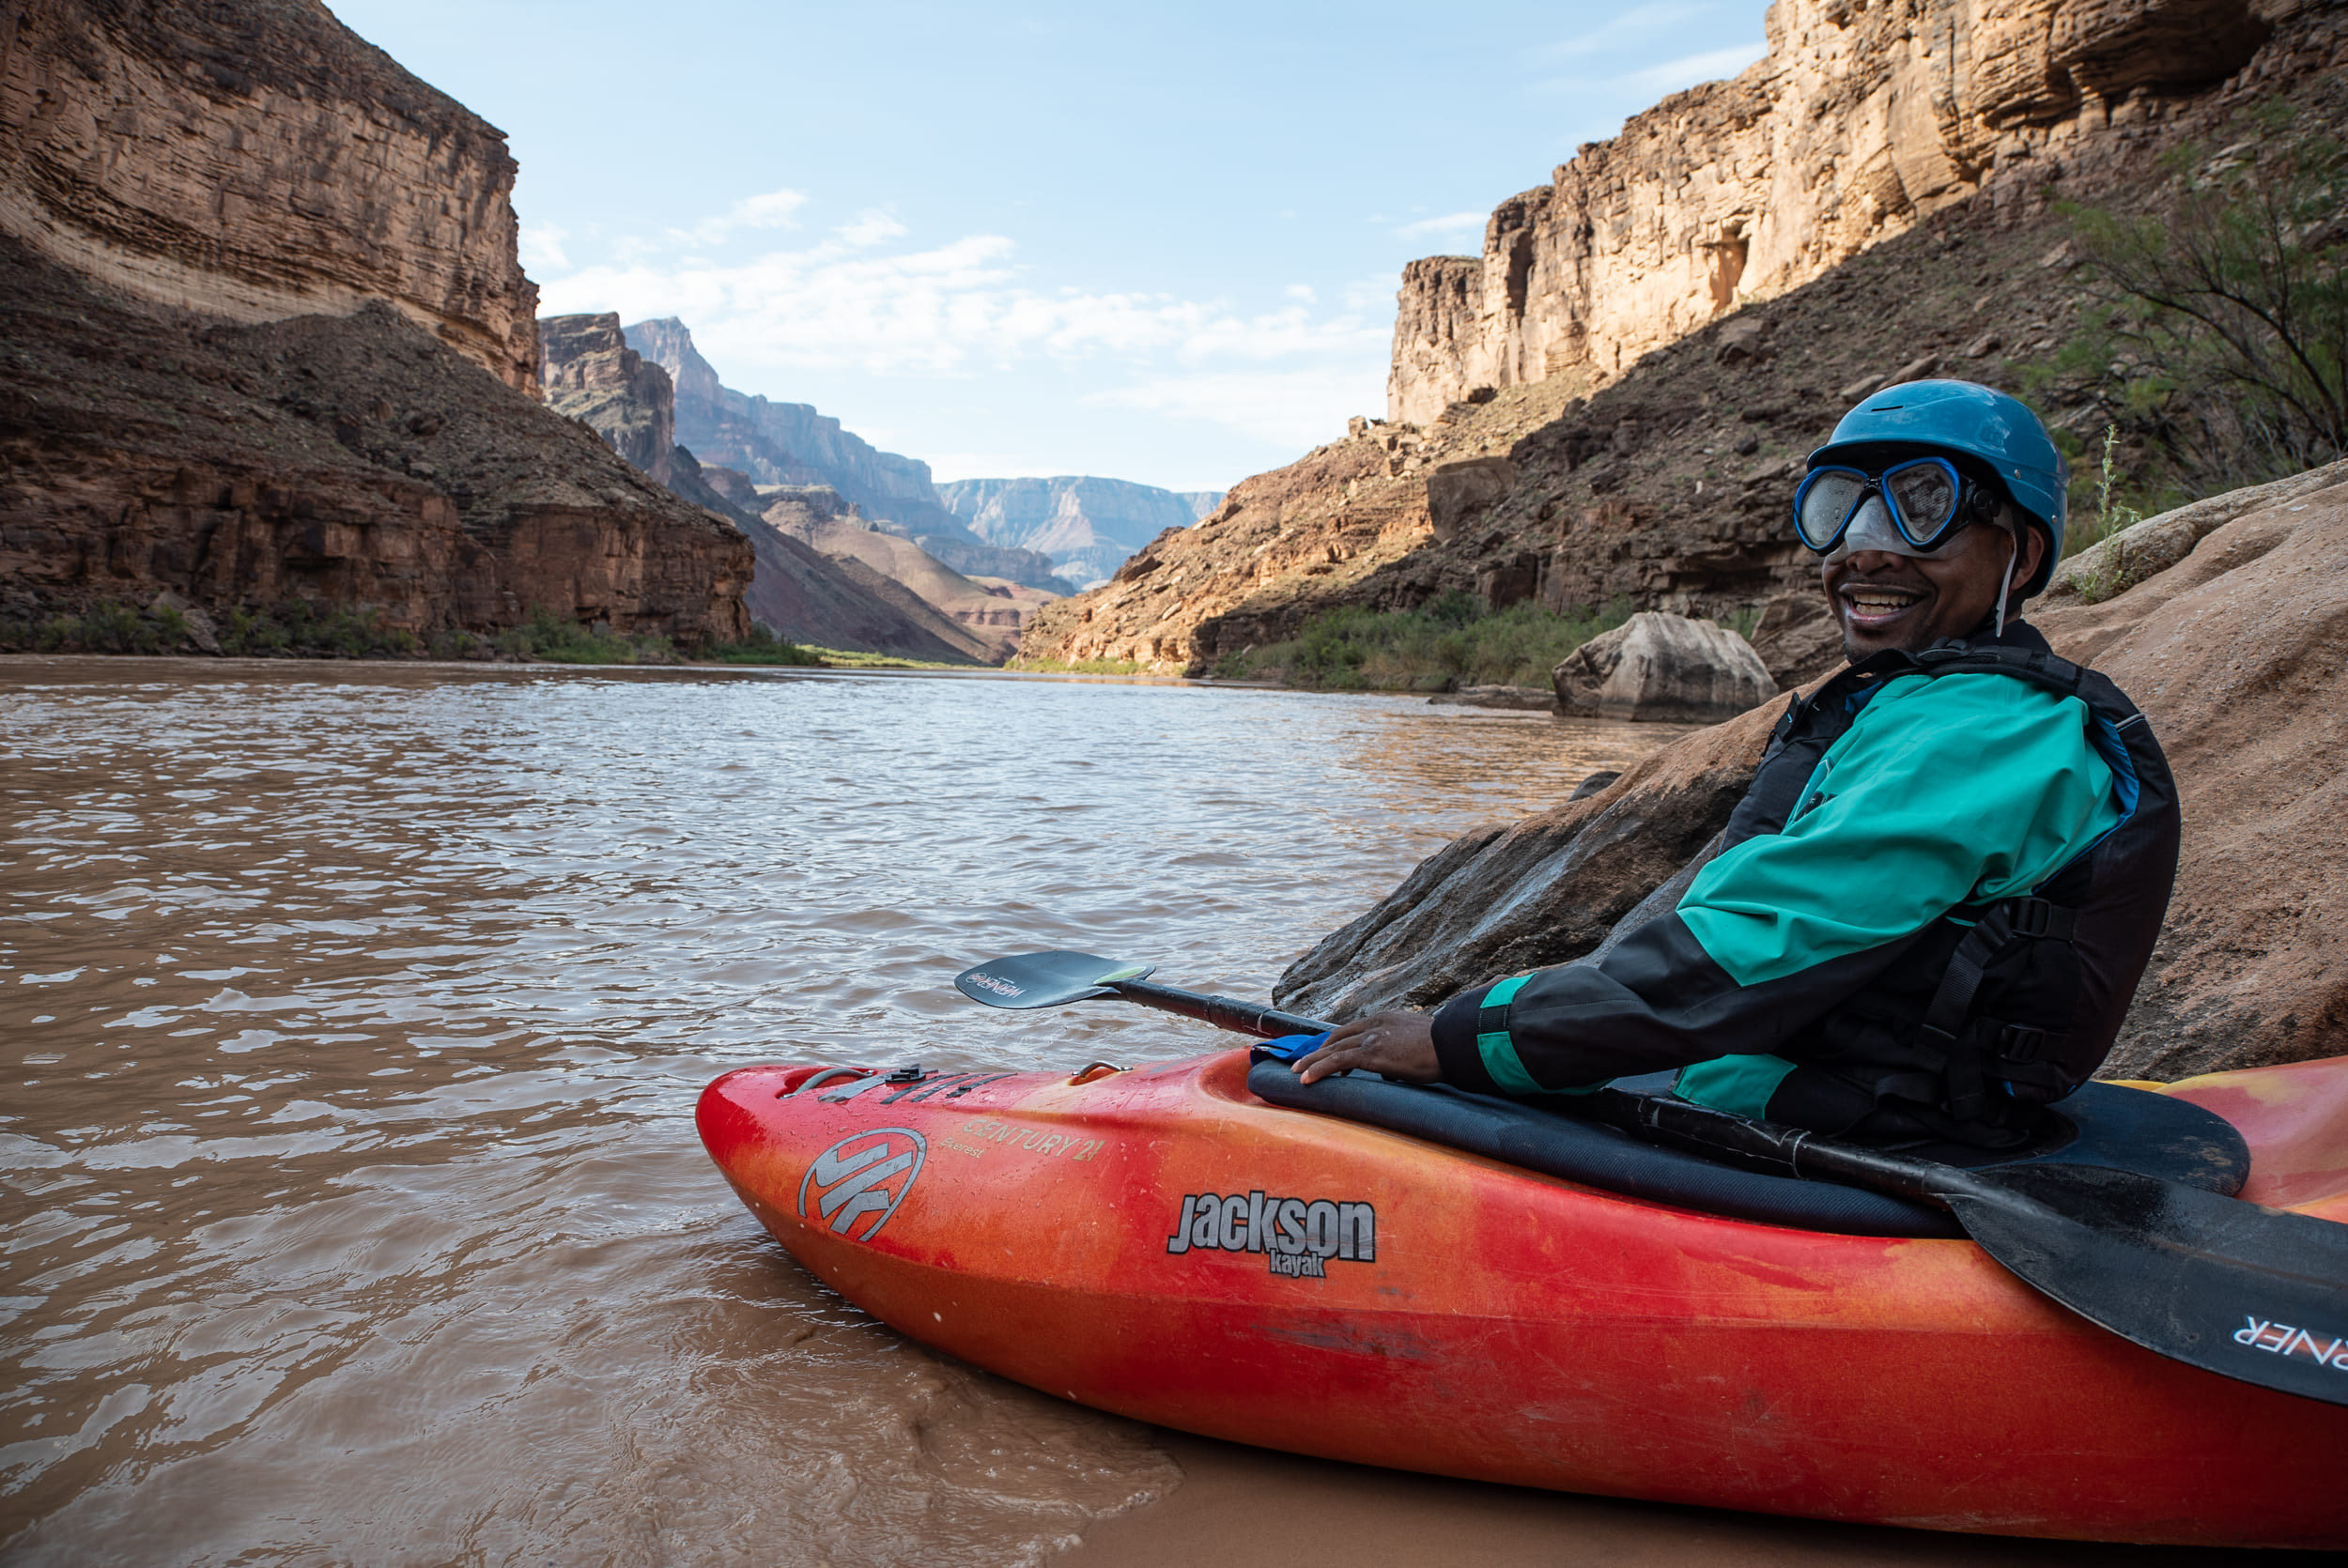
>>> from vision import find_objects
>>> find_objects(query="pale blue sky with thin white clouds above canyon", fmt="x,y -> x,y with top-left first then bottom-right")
333,0 -> 1764,491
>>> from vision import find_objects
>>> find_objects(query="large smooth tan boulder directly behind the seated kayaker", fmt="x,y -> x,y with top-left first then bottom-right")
1275,463 -> 2348,1080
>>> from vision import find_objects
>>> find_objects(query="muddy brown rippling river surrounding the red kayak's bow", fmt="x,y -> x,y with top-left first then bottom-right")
0,660 -> 2235,1568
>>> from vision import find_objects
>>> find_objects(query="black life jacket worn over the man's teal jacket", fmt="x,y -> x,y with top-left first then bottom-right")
1722,624 -> 2179,1148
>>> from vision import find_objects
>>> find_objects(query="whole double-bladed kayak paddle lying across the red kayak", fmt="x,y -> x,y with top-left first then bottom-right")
953,953 -> 2348,1404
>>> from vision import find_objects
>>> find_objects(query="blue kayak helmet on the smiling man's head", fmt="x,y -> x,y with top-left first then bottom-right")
1808,380 -> 2071,599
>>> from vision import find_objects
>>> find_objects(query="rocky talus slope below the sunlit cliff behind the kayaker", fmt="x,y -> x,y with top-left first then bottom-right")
1022,5 -> 2348,679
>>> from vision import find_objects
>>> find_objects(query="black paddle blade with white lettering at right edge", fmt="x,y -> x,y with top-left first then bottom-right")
1939,1164 -> 2348,1404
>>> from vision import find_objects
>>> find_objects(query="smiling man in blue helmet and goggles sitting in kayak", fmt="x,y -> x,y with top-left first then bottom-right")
1296,380 -> 2179,1148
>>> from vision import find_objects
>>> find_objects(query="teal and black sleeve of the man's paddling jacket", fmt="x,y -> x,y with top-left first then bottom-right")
1435,674 -> 2121,1094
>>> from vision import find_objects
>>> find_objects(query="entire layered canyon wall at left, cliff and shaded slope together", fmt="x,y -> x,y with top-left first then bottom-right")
0,0 -> 751,648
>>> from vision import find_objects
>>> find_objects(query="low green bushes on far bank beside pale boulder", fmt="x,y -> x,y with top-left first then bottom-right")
1214,592 -> 1632,693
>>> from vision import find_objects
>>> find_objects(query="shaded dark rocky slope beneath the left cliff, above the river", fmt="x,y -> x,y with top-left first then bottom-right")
0,239 -> 751,648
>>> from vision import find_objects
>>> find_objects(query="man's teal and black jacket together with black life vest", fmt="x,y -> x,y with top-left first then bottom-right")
1435,623 -> 2179,1144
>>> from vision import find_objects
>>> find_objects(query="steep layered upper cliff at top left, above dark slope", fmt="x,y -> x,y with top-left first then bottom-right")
0,0 -> 538,392
